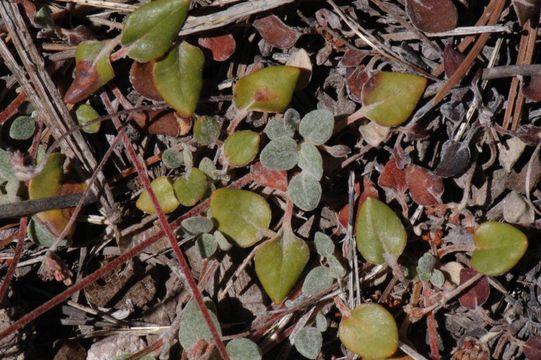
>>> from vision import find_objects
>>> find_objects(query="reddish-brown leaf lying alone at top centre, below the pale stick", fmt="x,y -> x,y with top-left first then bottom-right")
254,15 -> 301,50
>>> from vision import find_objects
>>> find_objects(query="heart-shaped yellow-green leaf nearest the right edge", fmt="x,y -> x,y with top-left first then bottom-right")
471,221 -> 528,276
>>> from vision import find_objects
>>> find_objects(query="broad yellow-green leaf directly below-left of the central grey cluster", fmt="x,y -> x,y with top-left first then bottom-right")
210,188 -> 272,247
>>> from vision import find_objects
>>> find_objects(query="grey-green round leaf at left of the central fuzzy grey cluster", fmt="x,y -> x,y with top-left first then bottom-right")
259,137 -> 298,170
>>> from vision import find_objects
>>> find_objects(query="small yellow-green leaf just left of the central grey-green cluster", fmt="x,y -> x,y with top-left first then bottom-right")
224,130 -> 260,167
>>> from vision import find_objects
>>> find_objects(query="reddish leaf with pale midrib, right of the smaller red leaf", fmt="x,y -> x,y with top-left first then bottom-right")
406,165 -> 444,206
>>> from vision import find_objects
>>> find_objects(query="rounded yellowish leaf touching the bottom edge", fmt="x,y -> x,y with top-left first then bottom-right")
338,304 -> 398,359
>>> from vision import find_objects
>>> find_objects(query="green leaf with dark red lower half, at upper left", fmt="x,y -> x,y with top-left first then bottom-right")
64,41 -> 115,104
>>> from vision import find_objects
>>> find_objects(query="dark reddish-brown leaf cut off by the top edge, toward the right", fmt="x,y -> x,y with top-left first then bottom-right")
406,0 -> 458,32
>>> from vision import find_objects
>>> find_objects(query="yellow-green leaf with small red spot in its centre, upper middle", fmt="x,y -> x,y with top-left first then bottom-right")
233,65 -> 301,112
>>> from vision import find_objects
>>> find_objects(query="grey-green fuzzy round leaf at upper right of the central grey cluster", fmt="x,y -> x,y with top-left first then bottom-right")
299,110 -> 334,145
